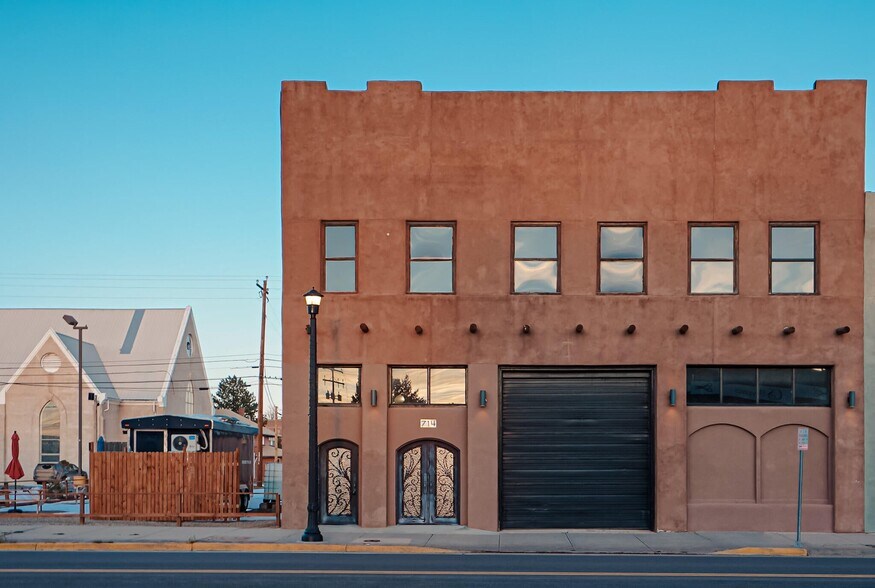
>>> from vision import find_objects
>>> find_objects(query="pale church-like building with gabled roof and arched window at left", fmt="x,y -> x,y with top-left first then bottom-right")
0,307 -> 212,479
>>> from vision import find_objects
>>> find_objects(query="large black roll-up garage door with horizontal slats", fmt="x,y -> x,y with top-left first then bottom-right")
500,369 -> 653,529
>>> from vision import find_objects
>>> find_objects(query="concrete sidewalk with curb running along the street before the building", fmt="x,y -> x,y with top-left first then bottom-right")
0,515 -> 875,557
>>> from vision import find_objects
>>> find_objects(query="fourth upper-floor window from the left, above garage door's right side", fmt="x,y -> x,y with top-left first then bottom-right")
599,223 -> 645,294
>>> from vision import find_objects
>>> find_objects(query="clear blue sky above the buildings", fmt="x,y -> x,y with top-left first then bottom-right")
0,0 -> 875,403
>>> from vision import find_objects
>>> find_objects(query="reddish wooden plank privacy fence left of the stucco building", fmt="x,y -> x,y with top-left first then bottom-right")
89,451 -> 241,522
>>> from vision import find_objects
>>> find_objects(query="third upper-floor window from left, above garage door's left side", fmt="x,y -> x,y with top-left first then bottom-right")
513,224 -> 559,294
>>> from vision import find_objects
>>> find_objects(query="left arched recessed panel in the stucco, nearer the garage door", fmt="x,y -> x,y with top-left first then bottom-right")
687,424 -> 756,502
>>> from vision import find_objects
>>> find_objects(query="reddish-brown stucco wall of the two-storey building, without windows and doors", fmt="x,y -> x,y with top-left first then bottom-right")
281,81 -> 866,532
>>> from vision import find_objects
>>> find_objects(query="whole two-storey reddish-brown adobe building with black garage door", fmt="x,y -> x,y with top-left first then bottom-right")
281,81 -> 866,532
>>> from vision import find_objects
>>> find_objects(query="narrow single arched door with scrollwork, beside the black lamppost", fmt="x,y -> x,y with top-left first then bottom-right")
319,439 -> 358,525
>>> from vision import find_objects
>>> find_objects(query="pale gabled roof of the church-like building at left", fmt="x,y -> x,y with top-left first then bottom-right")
0,307 -> 191,400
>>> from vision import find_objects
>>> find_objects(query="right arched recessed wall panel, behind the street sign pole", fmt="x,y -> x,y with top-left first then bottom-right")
762,425 -> 830,504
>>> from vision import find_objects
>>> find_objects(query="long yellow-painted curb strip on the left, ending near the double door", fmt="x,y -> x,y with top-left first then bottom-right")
0,542 -> 454,553
